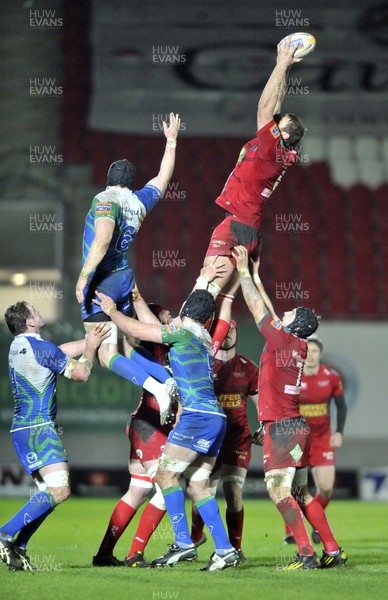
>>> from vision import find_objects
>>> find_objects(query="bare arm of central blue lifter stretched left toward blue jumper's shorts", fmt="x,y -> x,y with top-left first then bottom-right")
93,292 -> 162,344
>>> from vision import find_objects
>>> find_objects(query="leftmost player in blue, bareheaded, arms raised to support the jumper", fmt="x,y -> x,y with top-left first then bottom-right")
0,301 -> 110,571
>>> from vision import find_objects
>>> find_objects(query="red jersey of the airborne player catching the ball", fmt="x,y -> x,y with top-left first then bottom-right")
216,119 -> 297,229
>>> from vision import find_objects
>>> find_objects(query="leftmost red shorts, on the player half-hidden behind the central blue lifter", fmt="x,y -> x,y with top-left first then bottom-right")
127,417 -> 168,463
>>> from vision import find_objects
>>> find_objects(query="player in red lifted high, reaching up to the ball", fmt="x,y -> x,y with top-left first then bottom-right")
194,40 -> 305,354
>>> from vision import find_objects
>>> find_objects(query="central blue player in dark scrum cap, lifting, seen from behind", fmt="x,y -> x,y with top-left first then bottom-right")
97,278 -> 240,571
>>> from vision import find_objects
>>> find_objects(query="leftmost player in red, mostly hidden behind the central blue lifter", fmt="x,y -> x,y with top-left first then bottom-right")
93,302 -> 172,568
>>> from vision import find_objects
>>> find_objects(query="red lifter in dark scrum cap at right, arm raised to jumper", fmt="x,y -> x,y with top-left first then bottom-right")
233,246 -> 348,571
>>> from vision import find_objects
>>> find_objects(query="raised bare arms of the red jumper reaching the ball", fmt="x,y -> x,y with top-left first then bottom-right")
257,36 -> 303,129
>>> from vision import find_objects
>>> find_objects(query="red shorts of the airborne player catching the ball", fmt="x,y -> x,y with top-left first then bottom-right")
206,217 -> 261,265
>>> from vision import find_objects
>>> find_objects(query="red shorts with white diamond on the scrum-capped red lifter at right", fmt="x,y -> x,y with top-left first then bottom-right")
263,417 -> 311,473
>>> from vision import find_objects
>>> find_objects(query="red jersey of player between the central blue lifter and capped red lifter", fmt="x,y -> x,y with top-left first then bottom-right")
214,354 -> 259,432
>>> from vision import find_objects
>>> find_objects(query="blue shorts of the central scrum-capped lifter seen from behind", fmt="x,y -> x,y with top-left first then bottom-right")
166,409 -> 226,457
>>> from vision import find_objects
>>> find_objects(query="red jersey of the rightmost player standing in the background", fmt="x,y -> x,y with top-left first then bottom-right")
299,364 -> 344,433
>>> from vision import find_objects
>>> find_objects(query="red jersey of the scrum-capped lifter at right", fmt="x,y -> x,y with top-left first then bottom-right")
258,315 -> 307,421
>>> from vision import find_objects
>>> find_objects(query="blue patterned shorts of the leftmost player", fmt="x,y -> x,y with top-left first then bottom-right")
11,424 -> 68,475
